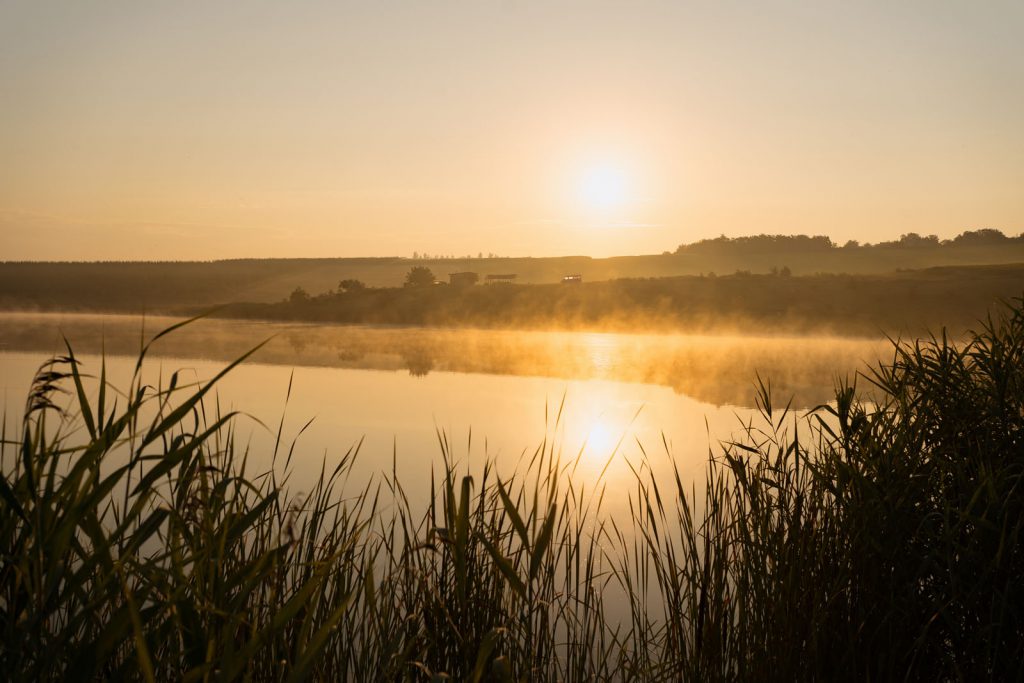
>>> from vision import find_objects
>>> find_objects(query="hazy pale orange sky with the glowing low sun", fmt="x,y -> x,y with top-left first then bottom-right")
0,0 -> 1024,260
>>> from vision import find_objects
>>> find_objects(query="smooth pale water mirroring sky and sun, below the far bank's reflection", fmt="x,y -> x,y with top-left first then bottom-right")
0,350 -> 720,528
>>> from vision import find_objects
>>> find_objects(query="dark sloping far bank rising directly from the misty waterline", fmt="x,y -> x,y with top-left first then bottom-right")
218,265 -> 1024,336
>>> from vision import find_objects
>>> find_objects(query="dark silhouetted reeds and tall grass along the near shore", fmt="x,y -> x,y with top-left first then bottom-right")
0,301 -> 1024,681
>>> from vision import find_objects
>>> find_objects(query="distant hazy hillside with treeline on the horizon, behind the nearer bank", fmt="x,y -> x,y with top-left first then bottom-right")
0,230 -> 1024,311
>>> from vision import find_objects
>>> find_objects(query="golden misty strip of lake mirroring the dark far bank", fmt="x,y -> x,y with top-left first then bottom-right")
0,313 -> 888,408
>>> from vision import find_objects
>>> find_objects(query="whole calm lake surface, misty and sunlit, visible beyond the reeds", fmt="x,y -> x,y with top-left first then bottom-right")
0,313 -> 887,505
